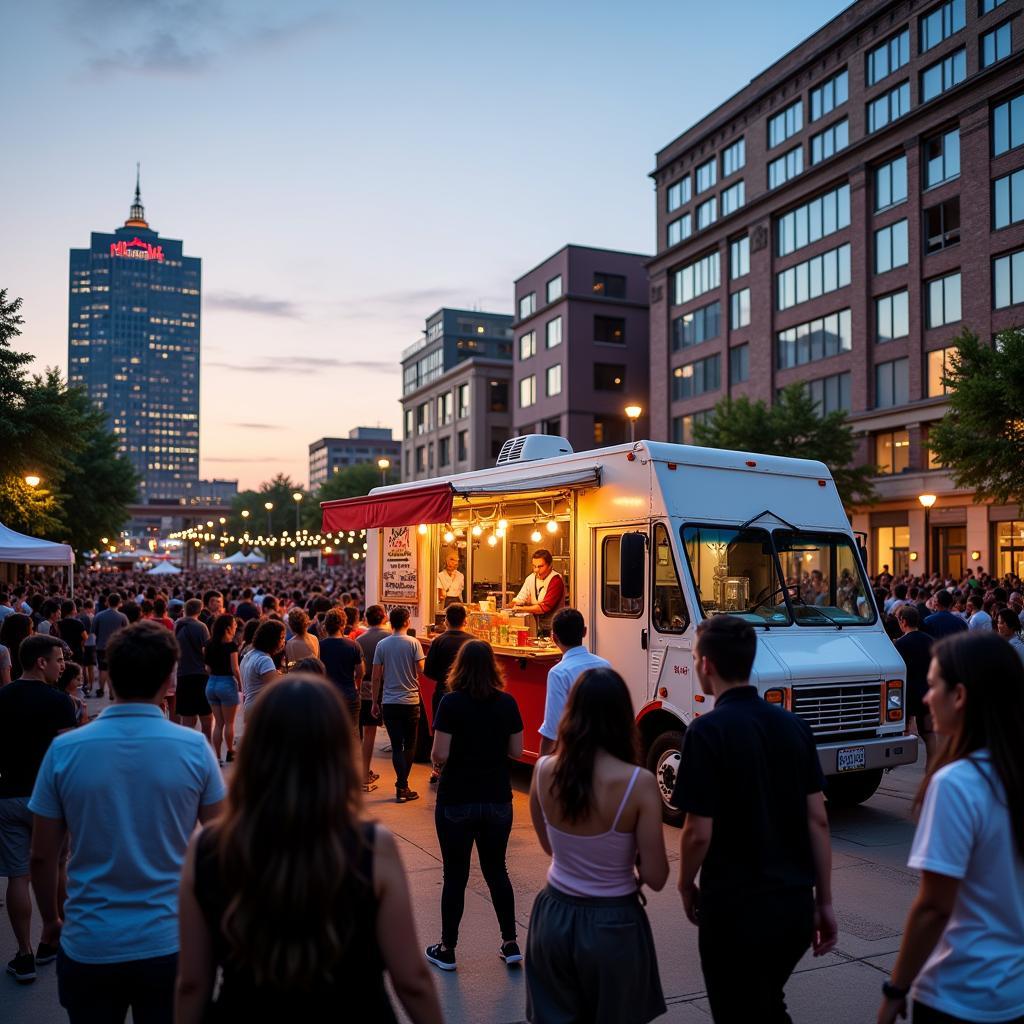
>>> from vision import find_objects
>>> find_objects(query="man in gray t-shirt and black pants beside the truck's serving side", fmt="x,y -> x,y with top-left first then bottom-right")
372,608 -> 424,804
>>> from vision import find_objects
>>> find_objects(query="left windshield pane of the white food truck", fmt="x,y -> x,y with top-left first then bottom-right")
683,526 -> 793,626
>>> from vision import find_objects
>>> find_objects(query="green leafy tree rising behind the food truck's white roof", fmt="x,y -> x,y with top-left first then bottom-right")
693,384 -> 877,507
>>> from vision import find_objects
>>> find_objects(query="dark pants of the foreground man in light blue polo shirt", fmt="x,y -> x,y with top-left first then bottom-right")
57,950 -> 178,1024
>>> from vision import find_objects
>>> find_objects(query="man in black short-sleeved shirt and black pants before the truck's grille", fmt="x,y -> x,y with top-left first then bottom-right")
673,615 -> 836,1024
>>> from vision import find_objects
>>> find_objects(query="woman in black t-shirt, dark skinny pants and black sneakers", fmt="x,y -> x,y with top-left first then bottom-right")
426,640 -> 522,971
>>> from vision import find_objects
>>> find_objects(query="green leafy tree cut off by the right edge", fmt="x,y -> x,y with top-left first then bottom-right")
928,328 -> 1024,505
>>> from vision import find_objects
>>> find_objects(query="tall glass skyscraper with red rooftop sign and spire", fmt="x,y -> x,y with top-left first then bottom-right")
68,174 -> 201,503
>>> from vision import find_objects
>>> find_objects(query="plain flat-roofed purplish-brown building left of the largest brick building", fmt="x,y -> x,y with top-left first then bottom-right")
512,245 -> 649,452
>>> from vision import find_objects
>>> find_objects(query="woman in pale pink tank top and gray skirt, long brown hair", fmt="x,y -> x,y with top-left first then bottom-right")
526,669 -> 669,1024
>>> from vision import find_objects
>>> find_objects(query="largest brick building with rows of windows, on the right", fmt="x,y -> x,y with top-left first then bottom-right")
649,0 -> 1024,573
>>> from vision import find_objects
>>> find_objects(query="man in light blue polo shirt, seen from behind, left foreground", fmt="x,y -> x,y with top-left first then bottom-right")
29,621 -> 224,1024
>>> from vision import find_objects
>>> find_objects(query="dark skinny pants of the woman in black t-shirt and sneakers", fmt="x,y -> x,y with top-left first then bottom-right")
434,804 -> 516,949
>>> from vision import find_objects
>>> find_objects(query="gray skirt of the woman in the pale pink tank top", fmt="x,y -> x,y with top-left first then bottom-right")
526,886 -> 666,1024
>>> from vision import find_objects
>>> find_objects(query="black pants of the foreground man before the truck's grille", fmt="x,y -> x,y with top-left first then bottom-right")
697,889 -> 814,1024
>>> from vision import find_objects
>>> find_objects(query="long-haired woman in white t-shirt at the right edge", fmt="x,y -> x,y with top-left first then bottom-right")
878,631 -> 1024,1024
